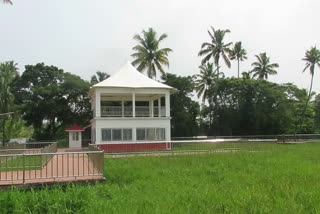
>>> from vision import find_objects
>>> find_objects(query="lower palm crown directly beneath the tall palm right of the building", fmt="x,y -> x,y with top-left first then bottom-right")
195,63 -> 223,102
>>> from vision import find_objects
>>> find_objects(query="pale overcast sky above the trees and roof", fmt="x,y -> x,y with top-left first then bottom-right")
0,0 -> 320,93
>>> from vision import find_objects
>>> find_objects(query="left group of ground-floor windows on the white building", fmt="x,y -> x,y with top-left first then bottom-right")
101,129 -> 132,141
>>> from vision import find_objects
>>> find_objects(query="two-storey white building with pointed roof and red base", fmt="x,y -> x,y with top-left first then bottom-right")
89,62 -> 175,152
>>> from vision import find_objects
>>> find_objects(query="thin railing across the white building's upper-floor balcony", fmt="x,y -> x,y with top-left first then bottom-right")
101,106 -> 166,117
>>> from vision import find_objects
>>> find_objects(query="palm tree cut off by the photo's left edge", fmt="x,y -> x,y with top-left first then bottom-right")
0,61 -> 18,144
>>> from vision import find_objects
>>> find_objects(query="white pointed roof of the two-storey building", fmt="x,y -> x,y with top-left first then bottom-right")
92,62 -> 175,90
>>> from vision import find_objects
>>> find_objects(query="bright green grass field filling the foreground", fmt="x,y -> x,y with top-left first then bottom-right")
0,143 -> 320,214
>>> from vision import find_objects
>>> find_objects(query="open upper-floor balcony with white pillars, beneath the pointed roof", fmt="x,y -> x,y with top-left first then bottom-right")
91,89 -> 170,118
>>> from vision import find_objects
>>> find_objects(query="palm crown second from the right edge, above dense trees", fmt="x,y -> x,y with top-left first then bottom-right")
251,52 -> 279,79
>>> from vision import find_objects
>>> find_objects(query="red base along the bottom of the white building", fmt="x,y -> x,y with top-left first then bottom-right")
99,143 -> 171,152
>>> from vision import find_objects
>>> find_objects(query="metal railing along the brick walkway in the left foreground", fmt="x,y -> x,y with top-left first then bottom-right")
0,144 -> 104,183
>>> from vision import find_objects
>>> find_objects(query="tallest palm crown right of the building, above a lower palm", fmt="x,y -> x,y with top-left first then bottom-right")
198,26 -> 232,76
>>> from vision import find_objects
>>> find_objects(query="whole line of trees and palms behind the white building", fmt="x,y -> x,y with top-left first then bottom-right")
0,27 -> 320,140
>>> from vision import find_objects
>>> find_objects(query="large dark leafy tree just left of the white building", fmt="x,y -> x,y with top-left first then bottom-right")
11,63 -> 91,140
